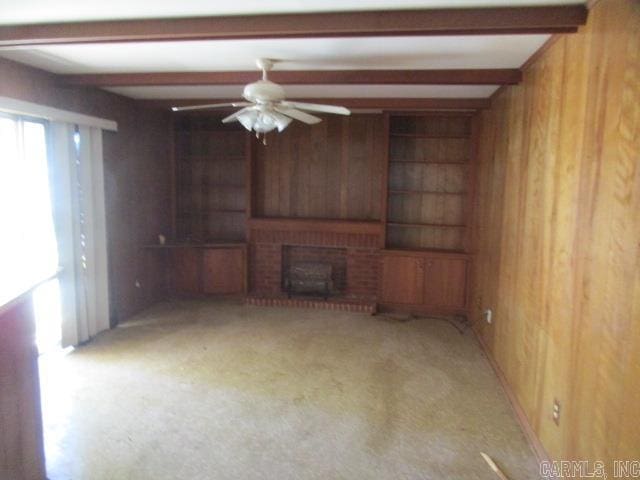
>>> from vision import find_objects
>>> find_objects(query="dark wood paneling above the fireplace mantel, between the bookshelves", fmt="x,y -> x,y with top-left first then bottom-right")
253,114 -> 387,220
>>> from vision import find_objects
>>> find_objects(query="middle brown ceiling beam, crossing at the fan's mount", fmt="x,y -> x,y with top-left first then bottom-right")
60,69 -> 522,87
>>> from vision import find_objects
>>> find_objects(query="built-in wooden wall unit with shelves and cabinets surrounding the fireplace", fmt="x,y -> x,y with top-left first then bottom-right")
168,112 -> 474,314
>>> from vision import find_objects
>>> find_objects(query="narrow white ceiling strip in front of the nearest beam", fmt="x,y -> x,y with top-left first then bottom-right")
0,0 -> 585,25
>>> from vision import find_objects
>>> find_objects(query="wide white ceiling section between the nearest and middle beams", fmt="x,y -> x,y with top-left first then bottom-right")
0,35 -> 549,77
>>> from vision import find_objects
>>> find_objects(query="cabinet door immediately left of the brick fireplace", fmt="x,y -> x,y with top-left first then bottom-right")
202,248 -> 244,294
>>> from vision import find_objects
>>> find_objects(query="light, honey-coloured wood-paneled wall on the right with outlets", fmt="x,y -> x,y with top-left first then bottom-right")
473,0 -> 640,475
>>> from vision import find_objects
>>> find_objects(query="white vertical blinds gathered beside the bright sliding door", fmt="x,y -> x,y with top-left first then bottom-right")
49,122 -> 109,346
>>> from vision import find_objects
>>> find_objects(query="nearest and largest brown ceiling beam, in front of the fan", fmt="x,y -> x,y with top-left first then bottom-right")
0,5 -> 587,47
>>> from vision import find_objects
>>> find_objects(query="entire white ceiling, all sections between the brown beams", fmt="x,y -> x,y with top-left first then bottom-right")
0,0 -> 584,99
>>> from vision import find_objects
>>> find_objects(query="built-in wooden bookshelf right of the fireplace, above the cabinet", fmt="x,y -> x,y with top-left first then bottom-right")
386,113 -> 471,252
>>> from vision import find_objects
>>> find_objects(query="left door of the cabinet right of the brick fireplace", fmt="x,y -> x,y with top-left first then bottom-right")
380,255 -> 424,304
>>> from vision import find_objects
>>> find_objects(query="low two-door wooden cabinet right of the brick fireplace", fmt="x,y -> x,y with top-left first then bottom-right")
380,250 -> 468,313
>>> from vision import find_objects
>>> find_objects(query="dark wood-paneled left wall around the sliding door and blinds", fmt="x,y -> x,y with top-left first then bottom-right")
0,59 -> 171,323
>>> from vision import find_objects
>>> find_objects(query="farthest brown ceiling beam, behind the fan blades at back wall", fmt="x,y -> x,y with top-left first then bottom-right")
136,98 -> 491,113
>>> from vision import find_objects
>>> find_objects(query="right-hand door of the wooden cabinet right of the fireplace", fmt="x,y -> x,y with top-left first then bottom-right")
424,258 -> 467,309
